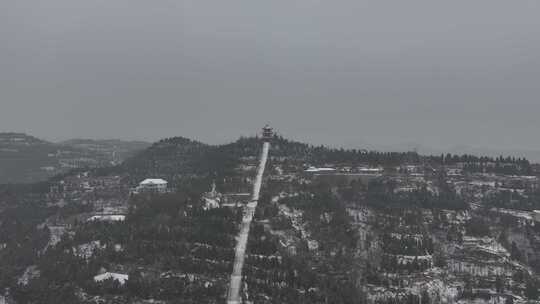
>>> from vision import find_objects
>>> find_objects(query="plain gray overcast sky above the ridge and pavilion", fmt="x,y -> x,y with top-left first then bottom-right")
0,0 -> 540,150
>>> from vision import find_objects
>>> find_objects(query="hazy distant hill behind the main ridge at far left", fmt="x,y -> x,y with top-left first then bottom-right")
0,132 -> 149,184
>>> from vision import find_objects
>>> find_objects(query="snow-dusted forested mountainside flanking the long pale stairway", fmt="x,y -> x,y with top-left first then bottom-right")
0,136 -> 540,304
